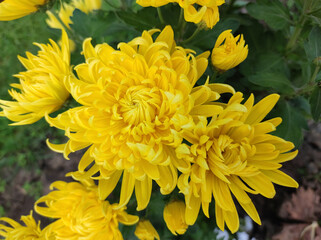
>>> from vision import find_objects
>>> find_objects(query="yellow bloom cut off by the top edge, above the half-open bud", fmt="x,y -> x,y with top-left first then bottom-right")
136,0 -> 225,28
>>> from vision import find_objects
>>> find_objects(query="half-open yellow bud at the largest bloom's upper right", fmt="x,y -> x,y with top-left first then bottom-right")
211,30 -> 249,72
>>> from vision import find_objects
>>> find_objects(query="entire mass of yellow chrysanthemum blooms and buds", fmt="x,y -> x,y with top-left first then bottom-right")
0,0 -> 298,240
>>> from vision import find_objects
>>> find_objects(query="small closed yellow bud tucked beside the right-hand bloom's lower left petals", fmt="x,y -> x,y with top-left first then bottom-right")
163,201 -> 188,235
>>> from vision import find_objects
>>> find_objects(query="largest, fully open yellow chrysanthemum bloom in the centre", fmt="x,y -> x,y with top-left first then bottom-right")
46,26 -> 234,210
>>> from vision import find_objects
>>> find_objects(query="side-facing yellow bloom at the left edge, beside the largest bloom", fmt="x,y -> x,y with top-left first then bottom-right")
0,29 -> 72,125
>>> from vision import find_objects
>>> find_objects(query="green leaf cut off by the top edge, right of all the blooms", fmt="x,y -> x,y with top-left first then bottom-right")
246,0 -> 291,30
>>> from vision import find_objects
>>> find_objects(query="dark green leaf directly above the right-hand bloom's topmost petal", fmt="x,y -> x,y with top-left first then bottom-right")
248,72 -> 294,94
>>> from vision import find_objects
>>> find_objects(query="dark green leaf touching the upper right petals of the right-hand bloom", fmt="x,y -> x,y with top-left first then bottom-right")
274,100 -> 308,147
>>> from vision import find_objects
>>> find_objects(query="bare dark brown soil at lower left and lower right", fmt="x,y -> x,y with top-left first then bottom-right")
0,124 -> 321,240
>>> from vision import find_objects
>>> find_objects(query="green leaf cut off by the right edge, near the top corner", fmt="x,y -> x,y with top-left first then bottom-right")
304,27 -> 321,61
